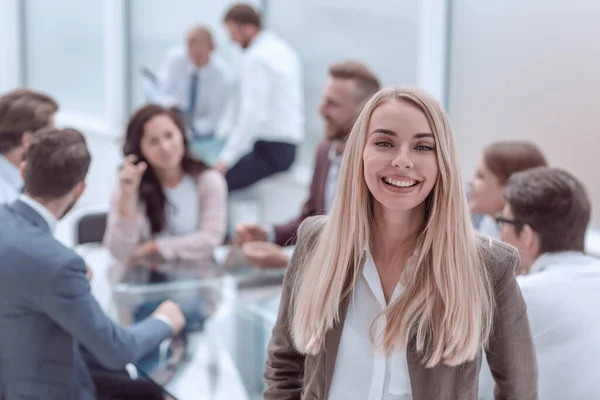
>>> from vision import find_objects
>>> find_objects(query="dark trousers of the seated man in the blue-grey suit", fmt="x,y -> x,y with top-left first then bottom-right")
92,371 -> 165,400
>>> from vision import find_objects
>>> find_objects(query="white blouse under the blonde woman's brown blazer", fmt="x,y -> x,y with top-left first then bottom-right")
328,253 -> 412,400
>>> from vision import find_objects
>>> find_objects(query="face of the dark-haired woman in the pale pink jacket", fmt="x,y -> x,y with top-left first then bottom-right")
140,114 -> 185,170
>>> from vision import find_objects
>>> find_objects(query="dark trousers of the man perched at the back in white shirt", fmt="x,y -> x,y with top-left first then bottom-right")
225,140 -> 296,192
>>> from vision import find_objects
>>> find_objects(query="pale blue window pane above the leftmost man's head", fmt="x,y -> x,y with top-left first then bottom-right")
22,0 -> 105,115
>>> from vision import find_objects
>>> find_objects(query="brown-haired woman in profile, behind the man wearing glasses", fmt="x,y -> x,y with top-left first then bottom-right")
469,141 -> 547,239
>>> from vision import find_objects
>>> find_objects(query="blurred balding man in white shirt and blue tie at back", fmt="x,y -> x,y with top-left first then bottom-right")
154,25 -> 231,164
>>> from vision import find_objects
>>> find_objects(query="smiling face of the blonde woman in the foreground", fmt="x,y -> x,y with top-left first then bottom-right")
363,101 -> 438,216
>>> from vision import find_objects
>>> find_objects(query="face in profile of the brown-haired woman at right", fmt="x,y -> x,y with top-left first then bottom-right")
469,157 -> 506,216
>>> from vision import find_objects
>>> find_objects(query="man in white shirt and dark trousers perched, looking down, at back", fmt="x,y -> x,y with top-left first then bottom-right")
215,4 -> 304,191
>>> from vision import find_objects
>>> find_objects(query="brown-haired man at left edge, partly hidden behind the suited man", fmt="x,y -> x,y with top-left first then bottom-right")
0,89 -> 58,204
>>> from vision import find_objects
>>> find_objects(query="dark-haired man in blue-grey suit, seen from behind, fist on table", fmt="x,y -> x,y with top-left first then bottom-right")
0,129 -> 185,400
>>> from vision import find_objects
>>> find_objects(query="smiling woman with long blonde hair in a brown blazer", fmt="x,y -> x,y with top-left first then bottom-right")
264,88 -> 537,400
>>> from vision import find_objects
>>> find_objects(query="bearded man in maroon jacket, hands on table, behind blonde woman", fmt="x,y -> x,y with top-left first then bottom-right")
236,61 -> 380,267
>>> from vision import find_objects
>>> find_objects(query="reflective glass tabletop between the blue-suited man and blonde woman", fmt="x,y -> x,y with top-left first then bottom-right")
82,247 -> 285,400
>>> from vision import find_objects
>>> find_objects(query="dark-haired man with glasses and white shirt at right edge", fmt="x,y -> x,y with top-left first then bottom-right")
480,167 -> 600,400
